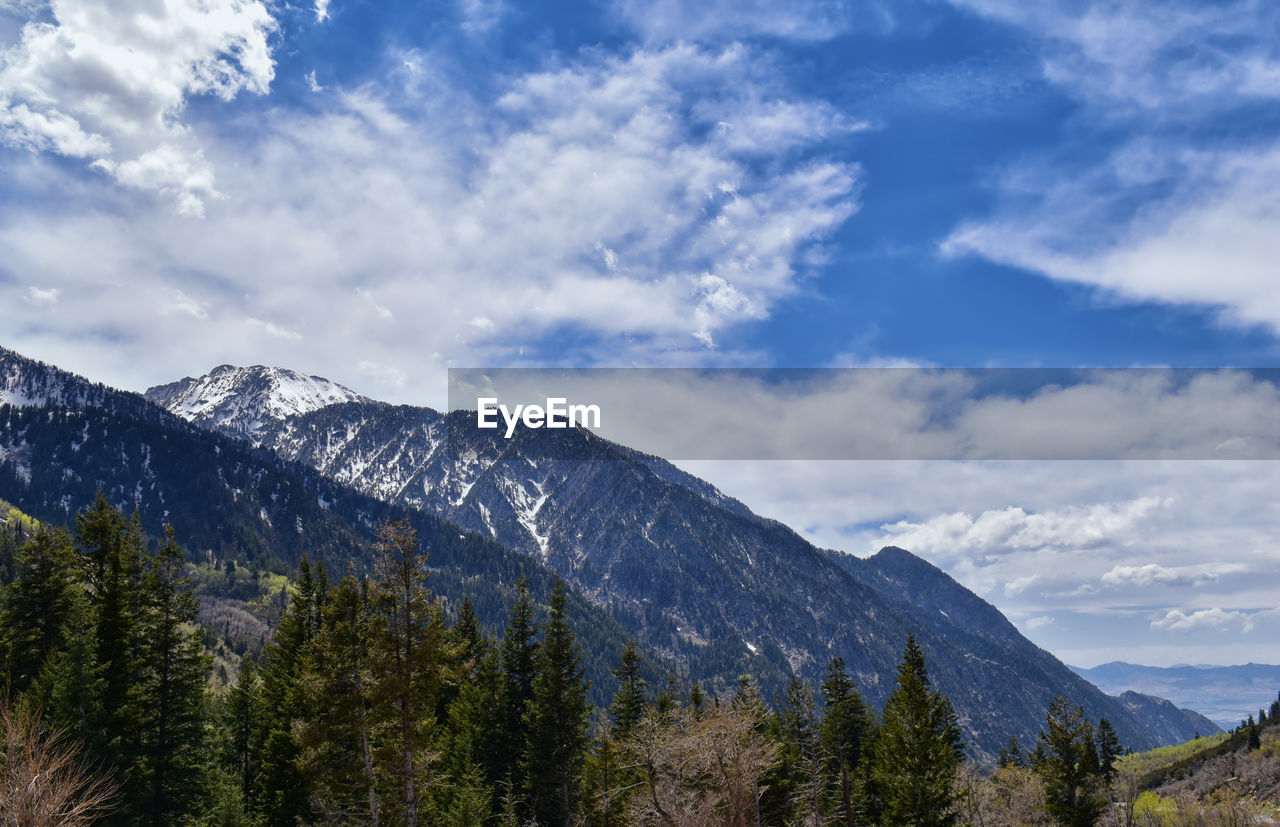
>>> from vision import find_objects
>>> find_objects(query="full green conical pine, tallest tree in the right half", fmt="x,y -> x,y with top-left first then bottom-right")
872,638 -> 964,827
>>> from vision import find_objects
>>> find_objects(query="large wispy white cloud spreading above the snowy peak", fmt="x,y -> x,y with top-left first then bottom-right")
0,46 -> 858,403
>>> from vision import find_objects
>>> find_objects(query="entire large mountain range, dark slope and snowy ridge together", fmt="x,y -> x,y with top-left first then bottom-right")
0,349 -> 1211,760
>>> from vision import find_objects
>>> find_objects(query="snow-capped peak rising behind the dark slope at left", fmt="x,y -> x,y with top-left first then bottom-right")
146,365 -> 372,439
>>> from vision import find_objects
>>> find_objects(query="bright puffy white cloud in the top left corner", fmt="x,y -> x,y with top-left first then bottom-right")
0,0 -> 275,215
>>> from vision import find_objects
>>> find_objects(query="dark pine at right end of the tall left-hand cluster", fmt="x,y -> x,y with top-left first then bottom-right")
138,526 -> 210,824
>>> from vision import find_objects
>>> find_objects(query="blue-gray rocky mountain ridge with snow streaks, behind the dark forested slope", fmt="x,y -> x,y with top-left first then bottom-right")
137,358 -> 1194,759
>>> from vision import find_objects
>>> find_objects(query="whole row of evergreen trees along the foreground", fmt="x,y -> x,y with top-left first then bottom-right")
0,497 -> 1228,827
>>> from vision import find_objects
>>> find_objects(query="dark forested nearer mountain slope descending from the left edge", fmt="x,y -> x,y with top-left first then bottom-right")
0,349 -> 673,703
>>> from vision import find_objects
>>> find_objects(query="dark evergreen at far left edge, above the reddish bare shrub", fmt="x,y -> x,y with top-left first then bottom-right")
0,526 -> 78,693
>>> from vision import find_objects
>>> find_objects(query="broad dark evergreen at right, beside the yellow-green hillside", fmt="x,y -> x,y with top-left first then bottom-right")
1032,695 -> 1106,827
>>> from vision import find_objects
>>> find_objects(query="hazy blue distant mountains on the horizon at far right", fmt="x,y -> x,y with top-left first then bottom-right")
1071,661 -> 1280,728
